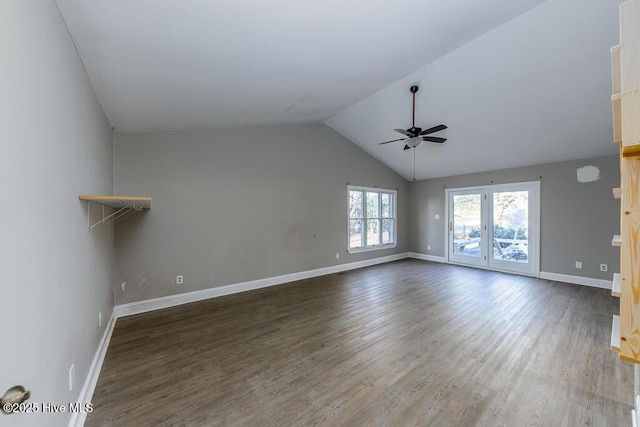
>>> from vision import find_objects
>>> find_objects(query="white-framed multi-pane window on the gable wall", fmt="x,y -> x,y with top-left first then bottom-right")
347,185 -> 396,253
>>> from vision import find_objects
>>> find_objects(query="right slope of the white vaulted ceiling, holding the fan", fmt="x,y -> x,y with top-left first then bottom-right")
327,0 -> 618,179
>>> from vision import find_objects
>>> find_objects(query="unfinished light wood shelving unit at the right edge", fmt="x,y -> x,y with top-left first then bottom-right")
611,0 -> 640,368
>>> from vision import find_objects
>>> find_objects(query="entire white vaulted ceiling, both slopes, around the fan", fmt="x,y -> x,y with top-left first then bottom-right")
57,0 -> 617,179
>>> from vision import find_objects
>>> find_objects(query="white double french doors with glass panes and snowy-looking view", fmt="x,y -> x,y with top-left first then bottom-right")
447,181 -> 540,275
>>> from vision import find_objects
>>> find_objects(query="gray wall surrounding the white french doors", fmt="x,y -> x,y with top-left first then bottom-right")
409,156 -> 620,280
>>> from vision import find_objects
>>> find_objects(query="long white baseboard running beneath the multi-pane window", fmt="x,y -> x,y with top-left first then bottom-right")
115,253 -> 409,318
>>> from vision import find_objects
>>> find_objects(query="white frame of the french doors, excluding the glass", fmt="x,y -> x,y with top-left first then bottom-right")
444,181 -> 540,277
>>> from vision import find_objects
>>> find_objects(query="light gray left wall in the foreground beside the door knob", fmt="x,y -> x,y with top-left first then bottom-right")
0,0 -> 114,427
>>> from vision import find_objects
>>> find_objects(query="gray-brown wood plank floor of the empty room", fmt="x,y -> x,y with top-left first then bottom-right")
86,260 -> 633,427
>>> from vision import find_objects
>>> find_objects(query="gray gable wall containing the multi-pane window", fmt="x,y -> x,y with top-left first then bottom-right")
114,124 -> 408,304
